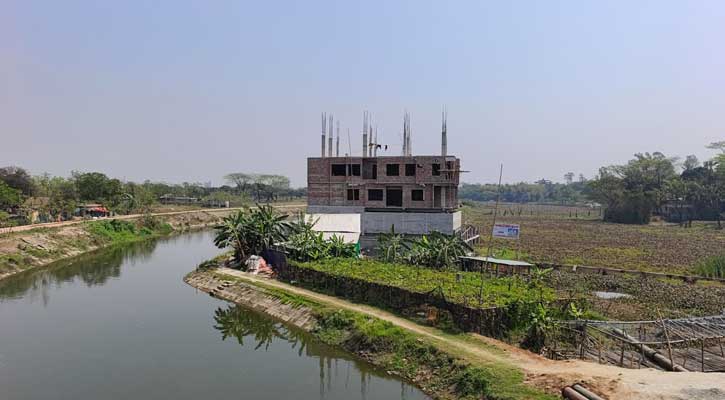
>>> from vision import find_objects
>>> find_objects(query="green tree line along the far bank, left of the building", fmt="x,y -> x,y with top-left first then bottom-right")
0,166 -> 306,226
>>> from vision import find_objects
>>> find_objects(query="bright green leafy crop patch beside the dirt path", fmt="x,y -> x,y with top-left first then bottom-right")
288,258 -> 554,307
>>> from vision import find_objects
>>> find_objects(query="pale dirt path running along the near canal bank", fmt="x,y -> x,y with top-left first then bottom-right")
218,268 -> 725,400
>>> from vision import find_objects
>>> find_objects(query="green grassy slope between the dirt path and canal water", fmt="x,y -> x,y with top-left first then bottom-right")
202,262 -> 556,400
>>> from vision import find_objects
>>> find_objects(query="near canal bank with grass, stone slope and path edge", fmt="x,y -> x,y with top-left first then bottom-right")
184,263 -> 558,399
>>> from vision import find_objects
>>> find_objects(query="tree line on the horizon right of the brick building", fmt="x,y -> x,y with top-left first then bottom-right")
458,141 -> 725,226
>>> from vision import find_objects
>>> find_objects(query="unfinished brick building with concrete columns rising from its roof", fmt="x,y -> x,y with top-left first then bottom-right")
307,111 -> 461,239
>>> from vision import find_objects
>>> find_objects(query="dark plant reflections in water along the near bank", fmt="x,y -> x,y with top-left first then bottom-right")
209,306 -> 424,399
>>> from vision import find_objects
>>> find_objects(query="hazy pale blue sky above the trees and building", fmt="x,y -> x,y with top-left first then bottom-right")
0,0 -> 725,186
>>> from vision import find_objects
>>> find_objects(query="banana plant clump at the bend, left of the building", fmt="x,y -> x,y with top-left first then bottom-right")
214,205 -> 293,263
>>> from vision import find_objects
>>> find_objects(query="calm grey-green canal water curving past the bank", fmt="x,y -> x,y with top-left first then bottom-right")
0,232 -> 426,400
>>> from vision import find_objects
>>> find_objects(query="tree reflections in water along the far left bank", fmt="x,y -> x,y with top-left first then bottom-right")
0,240 -> 157,305
